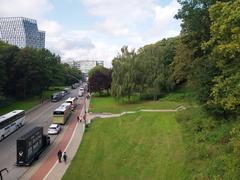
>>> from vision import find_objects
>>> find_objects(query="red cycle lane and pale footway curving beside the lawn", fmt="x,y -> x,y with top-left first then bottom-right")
20,95 -> 90,180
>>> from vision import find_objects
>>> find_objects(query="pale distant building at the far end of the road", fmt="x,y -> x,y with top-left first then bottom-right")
71,60 -> 104,75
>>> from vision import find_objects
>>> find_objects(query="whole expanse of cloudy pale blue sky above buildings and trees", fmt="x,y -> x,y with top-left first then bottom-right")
0,0 -> 181,67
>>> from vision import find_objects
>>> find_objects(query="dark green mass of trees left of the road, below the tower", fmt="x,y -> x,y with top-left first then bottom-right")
0,42 -> 81,98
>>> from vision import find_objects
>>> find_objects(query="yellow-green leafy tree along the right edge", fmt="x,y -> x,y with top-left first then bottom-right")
204,0 -> 240,113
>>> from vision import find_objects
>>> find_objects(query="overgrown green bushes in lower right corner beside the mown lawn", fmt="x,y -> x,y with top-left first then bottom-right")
176,108 -> 240,179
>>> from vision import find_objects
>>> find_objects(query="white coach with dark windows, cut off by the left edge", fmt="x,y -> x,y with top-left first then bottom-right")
0,110 -> 25,141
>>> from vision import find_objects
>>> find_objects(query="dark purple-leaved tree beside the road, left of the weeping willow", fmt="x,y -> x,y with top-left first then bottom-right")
88,65 -> 112,95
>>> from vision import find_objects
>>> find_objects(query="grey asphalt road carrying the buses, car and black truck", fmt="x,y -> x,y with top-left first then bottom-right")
0,88 -> 78,180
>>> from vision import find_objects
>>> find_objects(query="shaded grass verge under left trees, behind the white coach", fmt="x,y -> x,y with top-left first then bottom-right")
0,97 -> 41,115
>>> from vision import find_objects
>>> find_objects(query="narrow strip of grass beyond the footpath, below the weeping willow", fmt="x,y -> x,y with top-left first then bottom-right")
89,97 -> 187,113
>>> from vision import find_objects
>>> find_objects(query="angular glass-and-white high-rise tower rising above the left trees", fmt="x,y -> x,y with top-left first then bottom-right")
0,17 -> 45,48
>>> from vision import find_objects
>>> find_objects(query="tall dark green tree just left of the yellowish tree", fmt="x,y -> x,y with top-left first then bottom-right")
175,0 -> 229,103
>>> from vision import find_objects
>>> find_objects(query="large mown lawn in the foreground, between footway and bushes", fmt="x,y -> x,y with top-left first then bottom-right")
63,112 -> 185,180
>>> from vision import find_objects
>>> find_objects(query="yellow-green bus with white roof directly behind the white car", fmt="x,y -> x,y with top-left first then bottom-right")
53,103 -> 71,125
